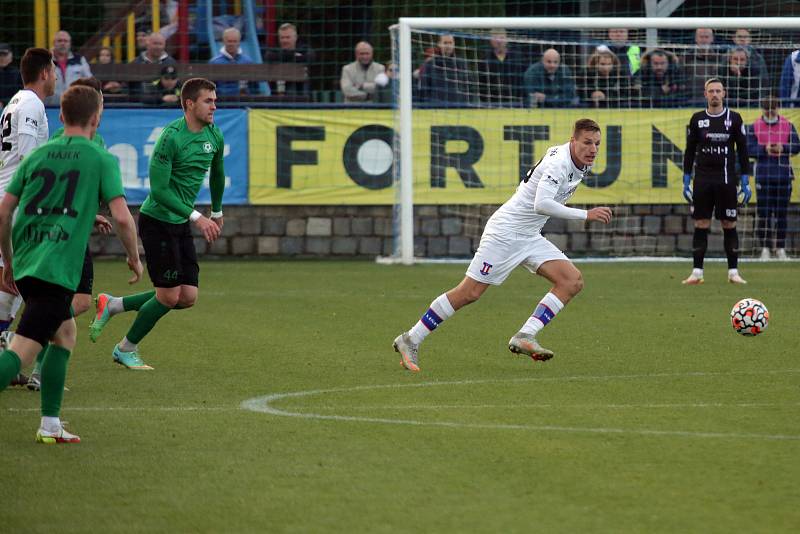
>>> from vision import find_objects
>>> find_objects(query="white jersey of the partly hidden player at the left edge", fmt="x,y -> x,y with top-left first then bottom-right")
0,89 -> 49,198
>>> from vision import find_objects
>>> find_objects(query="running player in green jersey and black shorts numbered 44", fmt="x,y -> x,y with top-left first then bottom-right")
89,78 -> 225,370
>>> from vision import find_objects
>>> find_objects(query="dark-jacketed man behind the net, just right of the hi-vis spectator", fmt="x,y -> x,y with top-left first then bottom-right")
634,48 -> 685,108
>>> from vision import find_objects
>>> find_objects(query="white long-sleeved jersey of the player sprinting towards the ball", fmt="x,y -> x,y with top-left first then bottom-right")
483,143 -> 590,236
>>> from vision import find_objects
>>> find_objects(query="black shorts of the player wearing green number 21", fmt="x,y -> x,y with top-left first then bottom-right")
16,276 -> 75,345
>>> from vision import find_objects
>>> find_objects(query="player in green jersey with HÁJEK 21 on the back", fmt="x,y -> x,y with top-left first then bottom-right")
0,87 -> 142,443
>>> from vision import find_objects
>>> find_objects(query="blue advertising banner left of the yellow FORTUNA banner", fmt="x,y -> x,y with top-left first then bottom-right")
47,108 -> 250,205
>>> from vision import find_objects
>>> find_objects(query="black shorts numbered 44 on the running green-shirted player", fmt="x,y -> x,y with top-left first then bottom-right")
139,213 -> 200,287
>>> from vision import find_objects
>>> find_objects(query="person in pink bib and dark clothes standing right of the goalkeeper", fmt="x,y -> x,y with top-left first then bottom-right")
747,96 -> 800,260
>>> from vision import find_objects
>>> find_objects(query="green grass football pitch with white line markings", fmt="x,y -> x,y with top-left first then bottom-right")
0,261 -> 800,533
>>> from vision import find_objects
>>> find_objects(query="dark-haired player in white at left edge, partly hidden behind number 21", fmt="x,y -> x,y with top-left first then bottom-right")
0,48 -> 56,385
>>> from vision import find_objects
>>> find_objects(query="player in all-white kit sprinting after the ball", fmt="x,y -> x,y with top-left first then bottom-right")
394,119 -> 611,371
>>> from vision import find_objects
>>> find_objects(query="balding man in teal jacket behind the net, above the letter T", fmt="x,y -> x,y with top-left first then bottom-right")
523,48 -> 578,108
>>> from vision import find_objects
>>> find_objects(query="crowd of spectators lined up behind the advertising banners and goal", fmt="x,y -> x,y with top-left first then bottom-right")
0,23 -> 800,108
